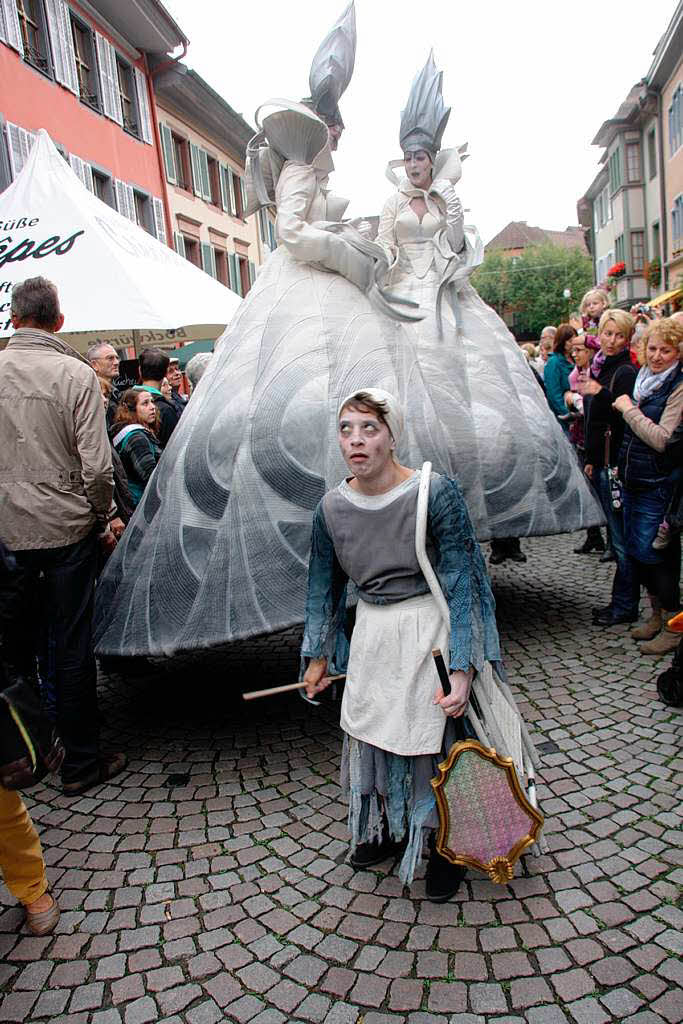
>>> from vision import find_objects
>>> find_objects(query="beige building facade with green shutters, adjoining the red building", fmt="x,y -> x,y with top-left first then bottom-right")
153,63 -> 275,296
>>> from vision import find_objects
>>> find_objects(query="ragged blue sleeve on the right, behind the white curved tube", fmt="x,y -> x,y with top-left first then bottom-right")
428,476 -> 501,672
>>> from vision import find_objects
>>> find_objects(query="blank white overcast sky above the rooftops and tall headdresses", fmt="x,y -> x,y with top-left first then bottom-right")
164,0 -> 676,242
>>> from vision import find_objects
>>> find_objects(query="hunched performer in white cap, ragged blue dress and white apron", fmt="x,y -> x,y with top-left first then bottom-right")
301,388 -> 501,902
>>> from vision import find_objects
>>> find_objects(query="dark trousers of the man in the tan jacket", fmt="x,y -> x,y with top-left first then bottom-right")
12,532 -> 99,782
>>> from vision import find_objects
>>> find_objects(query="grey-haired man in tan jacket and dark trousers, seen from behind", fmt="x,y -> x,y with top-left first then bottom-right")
0,278 -> 126,795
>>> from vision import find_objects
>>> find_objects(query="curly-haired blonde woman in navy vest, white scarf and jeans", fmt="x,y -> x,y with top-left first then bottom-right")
613,318 -> 683,654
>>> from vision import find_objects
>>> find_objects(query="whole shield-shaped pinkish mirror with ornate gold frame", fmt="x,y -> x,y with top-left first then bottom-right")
431,739 -> 544,885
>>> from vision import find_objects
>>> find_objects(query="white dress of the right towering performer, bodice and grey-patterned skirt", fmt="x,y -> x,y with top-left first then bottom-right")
378,172 -> 602,540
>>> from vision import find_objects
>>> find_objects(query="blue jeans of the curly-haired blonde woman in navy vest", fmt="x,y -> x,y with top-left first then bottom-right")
624,480 -> 681,611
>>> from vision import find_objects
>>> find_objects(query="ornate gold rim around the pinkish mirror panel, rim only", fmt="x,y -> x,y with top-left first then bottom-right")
431,739 -> 544,885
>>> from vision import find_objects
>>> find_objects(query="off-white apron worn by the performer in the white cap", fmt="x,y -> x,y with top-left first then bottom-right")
341,594 -> 449,757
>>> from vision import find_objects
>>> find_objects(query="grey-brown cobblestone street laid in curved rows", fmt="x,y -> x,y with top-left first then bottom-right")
0,536 -> 683,1024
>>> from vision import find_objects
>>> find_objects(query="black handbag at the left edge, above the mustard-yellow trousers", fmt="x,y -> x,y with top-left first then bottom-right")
0,678 -> 65,790
